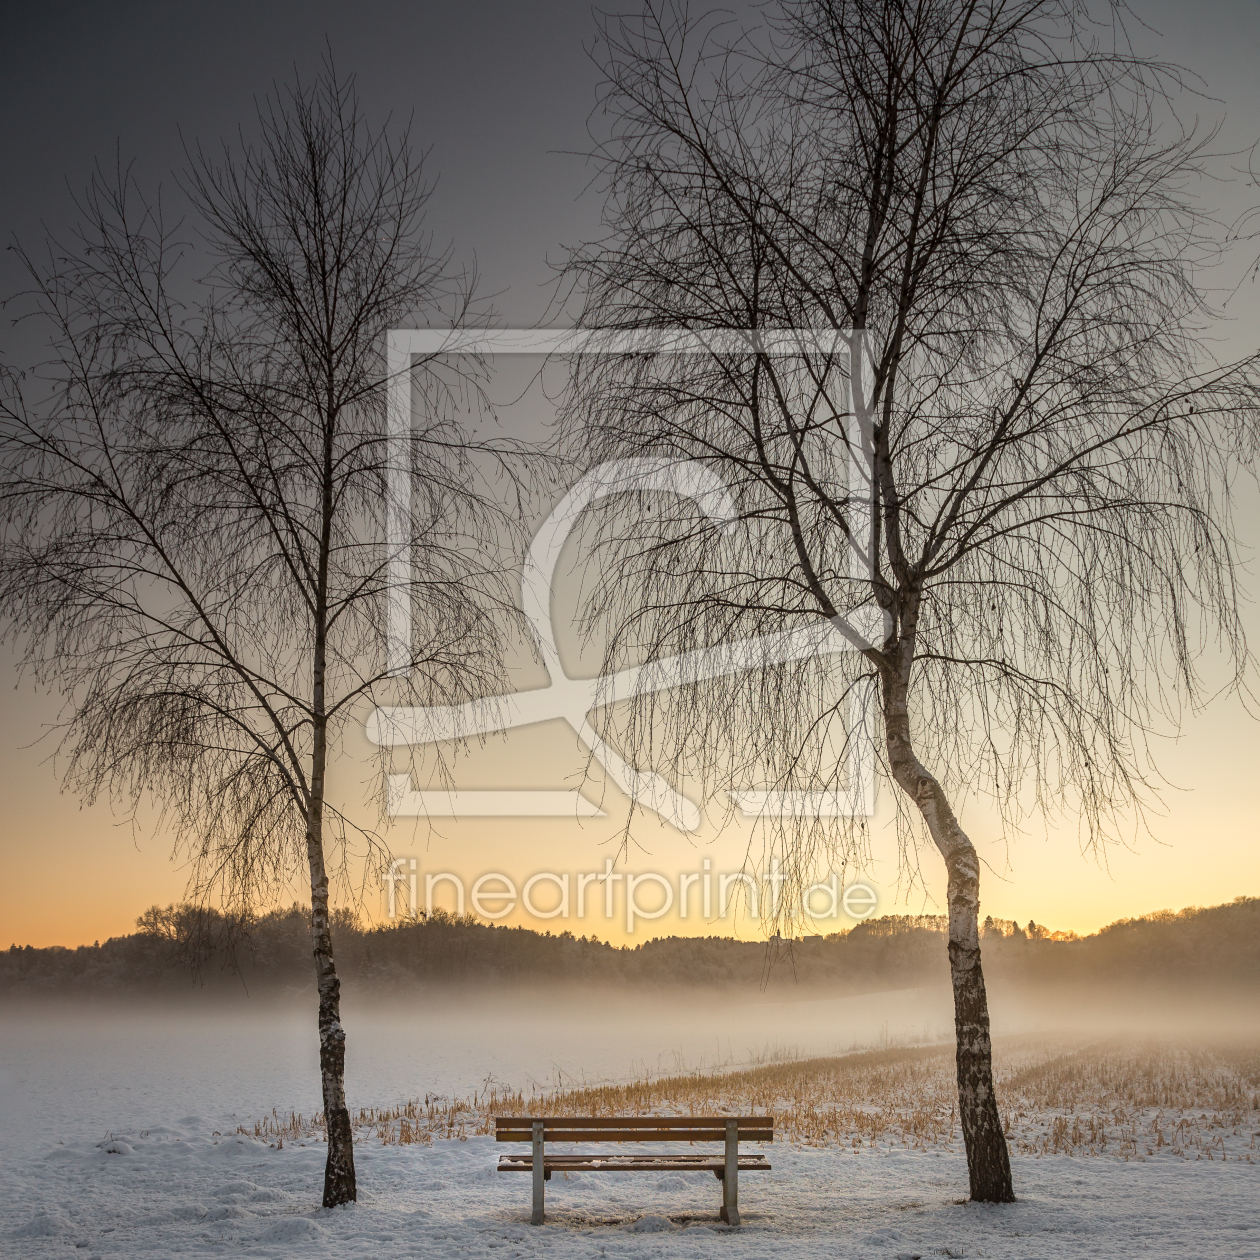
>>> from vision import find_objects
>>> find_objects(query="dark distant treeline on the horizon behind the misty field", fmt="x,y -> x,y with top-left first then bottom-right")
0,897 -> 1260,995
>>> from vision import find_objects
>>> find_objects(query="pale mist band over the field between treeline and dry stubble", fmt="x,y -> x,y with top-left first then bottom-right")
0,946 -> 1260,1139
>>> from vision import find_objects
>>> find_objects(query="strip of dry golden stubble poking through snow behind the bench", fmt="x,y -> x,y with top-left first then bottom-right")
238,1038 -> 1260,1163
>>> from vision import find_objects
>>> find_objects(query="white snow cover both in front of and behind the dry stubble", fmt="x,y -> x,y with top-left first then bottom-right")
0,994 -> 1260,1260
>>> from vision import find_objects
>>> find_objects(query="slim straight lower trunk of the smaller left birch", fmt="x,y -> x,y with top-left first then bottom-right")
306,723 -> 358,1207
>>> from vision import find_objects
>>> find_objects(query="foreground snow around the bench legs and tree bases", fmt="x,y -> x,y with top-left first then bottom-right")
0,1116 -> 1260,1260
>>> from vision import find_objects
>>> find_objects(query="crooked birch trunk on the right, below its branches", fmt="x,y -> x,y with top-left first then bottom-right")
883,670 -> 1016,1203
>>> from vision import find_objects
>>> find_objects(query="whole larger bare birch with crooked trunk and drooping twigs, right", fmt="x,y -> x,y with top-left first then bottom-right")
566,0 -> 1260,1202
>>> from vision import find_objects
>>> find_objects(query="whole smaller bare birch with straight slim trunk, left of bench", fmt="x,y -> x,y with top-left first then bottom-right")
0,63 -> 521,1206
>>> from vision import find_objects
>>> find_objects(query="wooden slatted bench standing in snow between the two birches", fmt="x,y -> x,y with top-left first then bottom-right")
494,1115 -> 775,1225
